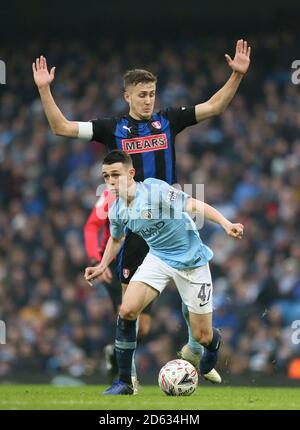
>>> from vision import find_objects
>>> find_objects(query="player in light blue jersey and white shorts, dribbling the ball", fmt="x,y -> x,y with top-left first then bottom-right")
85,151 -> 243,394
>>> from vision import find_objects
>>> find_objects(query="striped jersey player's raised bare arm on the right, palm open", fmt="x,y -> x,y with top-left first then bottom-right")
195,39 -> 251,122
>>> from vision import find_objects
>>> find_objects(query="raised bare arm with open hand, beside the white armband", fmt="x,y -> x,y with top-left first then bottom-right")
32,55 -> 79,137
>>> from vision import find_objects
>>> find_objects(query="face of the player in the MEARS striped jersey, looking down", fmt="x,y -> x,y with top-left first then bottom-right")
124,82 -> 156,119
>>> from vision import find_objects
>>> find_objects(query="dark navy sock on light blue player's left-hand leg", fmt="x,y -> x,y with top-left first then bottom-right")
115,315 -> 137,385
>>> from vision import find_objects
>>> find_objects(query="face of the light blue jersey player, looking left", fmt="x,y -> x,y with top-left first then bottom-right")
102,163 -> 135,197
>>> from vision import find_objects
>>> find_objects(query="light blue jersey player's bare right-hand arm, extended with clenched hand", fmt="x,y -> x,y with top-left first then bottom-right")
186,198 -> 244,239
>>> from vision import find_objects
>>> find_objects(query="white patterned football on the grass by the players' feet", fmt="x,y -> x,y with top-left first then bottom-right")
158,360 -> 198,396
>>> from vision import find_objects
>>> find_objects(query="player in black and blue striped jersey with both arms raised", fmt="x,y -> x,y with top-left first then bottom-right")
32,39 -> 251,382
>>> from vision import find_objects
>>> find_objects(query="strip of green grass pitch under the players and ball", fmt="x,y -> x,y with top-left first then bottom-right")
0,385 -> 300,411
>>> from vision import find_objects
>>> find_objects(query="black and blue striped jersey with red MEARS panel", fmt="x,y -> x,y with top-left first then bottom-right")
92,106 -> 197,184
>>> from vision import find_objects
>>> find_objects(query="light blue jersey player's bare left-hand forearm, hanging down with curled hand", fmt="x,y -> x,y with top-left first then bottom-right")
84,236 -> 125,286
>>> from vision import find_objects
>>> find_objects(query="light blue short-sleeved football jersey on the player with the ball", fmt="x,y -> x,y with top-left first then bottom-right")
109,178 -> 213,269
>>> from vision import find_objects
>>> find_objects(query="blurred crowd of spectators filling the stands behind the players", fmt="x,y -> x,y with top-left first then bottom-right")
0,33 -> 300,382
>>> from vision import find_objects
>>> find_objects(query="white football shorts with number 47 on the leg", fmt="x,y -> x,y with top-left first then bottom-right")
131,253 -> 213,314
